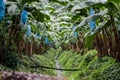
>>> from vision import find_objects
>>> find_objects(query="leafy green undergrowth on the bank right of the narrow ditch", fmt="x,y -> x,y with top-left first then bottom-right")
59,51 -> 120,80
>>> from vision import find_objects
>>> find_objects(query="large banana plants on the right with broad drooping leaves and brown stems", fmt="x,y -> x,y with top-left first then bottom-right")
71,0 -> 120,60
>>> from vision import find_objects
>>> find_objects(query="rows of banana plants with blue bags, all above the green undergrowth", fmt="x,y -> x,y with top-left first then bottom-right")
0,0 -> 120,67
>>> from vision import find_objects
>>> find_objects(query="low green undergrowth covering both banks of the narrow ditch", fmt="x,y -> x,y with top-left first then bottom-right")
0,48 -> 120,80
